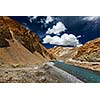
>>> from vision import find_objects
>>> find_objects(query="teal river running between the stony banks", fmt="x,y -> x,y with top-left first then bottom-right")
53,61 -> 100,83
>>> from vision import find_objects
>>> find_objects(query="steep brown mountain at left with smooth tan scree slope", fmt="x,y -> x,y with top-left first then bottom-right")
0,16 -> 54,64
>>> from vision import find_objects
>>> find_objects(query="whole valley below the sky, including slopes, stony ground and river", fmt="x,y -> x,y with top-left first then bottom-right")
0,16 -> 100,83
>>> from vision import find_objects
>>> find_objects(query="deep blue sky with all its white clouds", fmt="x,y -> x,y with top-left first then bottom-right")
10,16 -> 100,48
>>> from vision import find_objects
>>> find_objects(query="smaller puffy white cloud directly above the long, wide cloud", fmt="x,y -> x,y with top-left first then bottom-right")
46,22 -> 66,35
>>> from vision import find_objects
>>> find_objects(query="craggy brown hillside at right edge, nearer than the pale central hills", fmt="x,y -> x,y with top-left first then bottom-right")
74,38 -> 100,62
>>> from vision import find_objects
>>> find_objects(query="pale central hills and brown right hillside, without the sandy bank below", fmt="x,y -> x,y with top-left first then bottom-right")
49,38 -> 100,62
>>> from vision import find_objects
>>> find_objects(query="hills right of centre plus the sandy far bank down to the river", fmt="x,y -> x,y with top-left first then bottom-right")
49,38 -> 100,71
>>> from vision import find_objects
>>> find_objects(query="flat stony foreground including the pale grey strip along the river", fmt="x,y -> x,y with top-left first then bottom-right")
0,63 -> 81,83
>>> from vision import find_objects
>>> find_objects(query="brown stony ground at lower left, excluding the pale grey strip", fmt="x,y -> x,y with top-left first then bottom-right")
0,64 -> 62,83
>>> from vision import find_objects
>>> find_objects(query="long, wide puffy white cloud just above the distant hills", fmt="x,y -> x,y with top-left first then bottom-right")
43,33 -> 80,46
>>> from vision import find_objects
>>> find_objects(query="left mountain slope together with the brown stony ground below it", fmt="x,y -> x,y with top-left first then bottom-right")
0,16 -> 64,83
